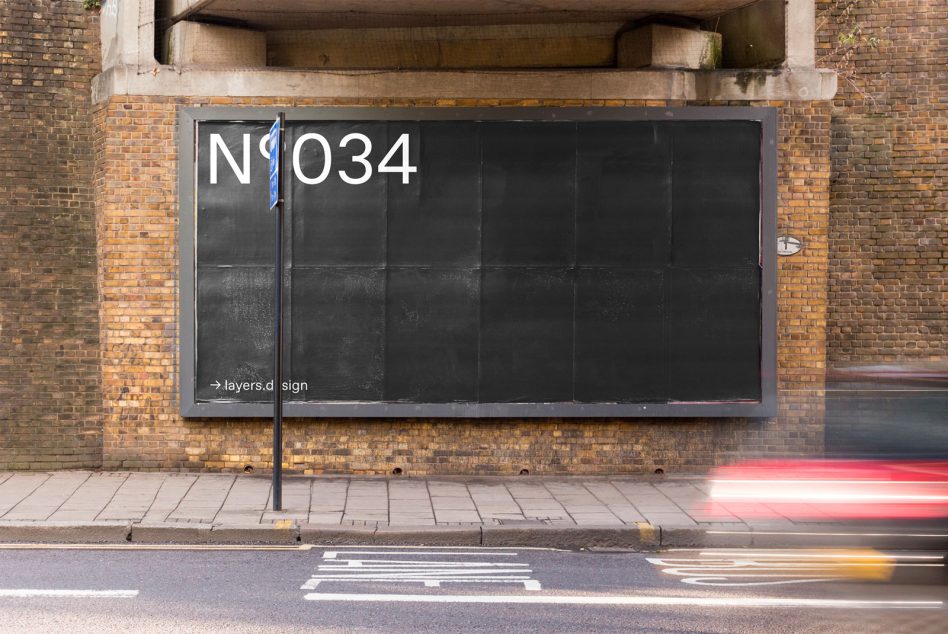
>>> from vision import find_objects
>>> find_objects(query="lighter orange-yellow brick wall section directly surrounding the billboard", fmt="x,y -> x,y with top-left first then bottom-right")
96,97 -> 829,475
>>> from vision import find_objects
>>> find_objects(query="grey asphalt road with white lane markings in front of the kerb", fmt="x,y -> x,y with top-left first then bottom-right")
0,546 -> 948,634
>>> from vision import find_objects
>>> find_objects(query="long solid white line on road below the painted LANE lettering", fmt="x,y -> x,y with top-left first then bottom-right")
303,592 -> 943,609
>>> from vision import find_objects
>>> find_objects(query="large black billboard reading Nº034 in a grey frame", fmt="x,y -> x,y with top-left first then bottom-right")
179,108 -> 776,418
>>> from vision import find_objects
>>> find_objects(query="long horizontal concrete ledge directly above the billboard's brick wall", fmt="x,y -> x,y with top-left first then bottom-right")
92,66 -> 836,103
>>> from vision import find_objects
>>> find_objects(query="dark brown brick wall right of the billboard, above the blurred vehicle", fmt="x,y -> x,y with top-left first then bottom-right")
818,0 -> 948,365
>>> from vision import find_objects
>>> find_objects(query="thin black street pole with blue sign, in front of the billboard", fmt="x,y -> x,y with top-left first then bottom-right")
270,112 -> 286,511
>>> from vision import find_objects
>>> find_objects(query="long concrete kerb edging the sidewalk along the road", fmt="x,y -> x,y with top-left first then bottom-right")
0,521 -> 948,551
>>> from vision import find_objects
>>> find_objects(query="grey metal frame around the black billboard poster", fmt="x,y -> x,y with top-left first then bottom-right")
177,106 -> 777,418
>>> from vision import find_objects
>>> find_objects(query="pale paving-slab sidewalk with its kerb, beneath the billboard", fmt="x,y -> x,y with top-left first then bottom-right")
0,471 -> 936,550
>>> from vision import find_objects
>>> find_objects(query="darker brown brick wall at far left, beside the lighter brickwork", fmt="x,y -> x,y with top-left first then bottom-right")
0,0 -> 102,469
